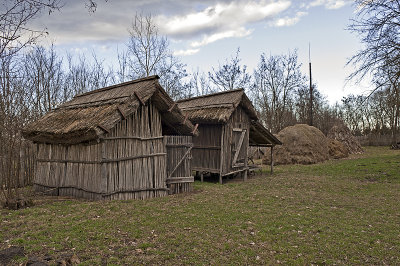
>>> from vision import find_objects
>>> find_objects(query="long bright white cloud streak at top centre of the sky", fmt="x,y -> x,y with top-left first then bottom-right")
156,0 -> 291,55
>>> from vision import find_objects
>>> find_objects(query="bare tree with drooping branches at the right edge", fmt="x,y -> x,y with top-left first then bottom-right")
348,0 -> 400,144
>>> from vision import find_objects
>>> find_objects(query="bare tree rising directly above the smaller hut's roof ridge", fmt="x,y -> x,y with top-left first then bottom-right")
208,48 -> 251,90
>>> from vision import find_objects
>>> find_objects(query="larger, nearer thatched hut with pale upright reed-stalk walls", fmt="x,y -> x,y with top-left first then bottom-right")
23,76 -> 197,199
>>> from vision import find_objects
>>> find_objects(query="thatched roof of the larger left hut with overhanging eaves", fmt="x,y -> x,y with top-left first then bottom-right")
23,76 -> 197,144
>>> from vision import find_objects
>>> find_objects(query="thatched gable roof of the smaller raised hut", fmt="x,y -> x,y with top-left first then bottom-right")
178,89 -> 258,124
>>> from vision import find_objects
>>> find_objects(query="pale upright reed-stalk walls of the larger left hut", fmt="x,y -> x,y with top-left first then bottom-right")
34,101 -> 167,199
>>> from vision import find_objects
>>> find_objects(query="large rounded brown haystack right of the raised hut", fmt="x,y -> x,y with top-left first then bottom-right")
263,124 -> 329,164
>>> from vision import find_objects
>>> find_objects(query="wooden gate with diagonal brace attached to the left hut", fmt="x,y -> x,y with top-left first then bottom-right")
165,136 -> 194,194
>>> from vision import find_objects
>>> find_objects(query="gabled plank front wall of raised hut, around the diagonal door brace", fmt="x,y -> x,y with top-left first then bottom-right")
221,106 -> 250,175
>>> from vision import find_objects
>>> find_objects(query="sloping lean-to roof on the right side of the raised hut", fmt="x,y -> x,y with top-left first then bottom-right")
249,120 -> 282,146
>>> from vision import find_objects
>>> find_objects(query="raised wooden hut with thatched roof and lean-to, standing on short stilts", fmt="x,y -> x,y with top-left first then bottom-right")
178,89 -> 281,183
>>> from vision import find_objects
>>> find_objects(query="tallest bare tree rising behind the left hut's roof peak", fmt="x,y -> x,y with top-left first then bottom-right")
122,14 -> 190,99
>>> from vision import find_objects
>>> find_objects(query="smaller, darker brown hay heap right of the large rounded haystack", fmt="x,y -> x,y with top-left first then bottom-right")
327,124 -> 364,154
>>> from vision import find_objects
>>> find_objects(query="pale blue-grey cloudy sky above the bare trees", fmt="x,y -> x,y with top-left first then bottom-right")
31,0 -> 369,103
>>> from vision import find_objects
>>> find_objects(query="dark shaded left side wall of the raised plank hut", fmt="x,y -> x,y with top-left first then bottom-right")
192,124 -> 222,173
